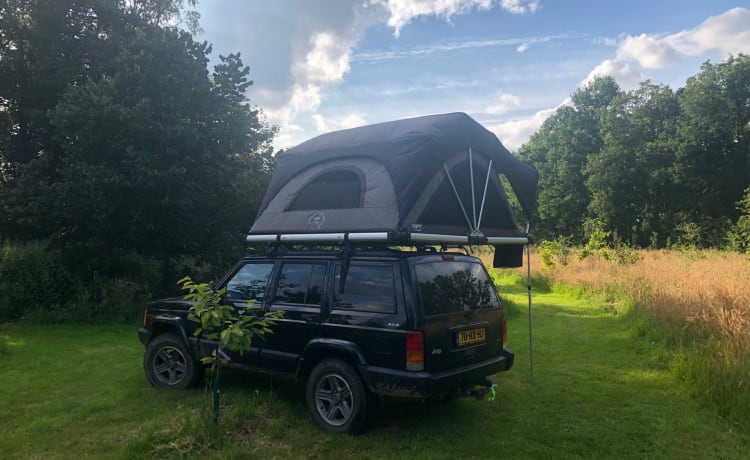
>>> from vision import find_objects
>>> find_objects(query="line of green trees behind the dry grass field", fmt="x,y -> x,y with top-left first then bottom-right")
517,58 -> 750,250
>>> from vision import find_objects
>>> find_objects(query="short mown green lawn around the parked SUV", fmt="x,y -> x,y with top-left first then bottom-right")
0,278 -> 750,459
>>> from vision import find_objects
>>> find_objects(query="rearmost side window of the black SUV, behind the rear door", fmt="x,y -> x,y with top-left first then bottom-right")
333,262 -> 396,313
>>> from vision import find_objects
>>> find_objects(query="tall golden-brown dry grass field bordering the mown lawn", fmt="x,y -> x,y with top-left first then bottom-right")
490,250 -> 750,420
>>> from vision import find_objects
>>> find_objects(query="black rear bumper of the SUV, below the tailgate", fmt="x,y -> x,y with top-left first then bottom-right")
359,350 -> 515,398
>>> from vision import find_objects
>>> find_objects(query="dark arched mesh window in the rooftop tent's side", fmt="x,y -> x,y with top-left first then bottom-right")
287,169 -> 362,211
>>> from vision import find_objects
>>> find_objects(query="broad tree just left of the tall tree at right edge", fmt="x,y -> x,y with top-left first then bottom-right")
586,82 -> 679,246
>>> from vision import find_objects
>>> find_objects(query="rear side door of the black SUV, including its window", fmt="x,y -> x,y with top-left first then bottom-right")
258,260 -> 328,374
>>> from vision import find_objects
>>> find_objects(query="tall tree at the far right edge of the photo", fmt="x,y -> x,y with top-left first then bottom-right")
674,54 -> 750,245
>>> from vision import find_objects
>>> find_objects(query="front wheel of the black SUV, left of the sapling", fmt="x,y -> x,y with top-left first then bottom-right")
143,334 -> 203,389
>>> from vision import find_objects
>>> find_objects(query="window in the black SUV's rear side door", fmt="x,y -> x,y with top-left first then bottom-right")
274,262 -> 327,306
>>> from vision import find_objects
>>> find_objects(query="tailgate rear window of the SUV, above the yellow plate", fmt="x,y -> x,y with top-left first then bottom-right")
414,261 -> 500,316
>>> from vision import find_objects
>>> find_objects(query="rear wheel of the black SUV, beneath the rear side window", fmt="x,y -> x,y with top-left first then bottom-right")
306,359 -> 377,434
